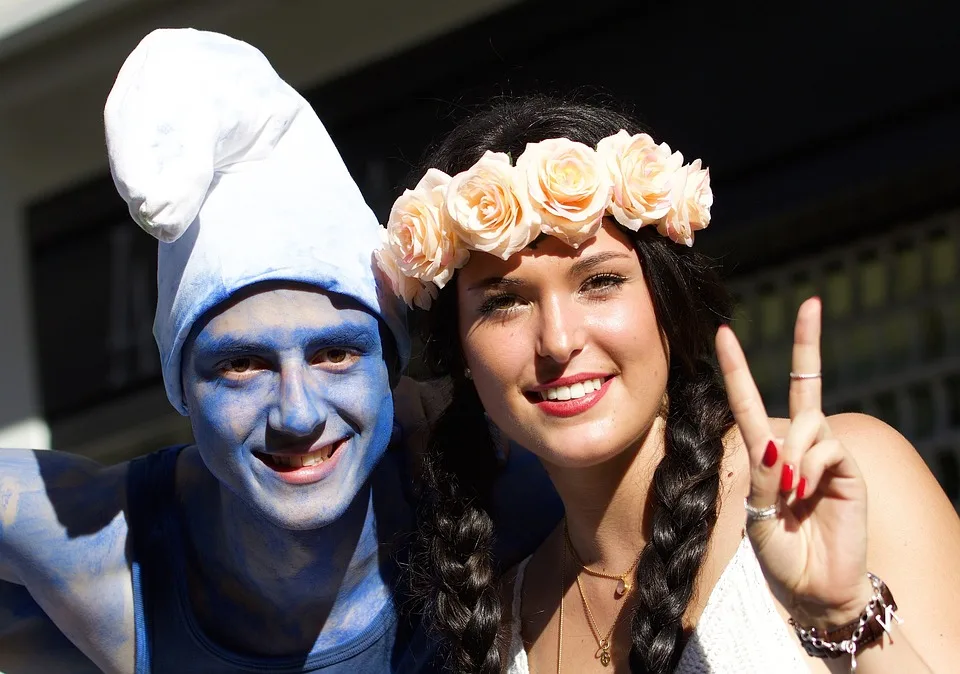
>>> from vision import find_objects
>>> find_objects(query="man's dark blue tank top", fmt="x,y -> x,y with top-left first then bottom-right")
127,447 -> 434,674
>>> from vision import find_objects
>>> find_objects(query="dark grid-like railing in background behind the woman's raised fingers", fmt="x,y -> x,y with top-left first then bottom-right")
730,210 -> 960,508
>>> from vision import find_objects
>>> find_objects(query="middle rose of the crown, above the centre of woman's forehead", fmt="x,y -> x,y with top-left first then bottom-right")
517,138 -> 613,248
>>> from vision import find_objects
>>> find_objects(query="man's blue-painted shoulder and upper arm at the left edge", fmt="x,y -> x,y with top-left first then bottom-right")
0,449 -> 134,672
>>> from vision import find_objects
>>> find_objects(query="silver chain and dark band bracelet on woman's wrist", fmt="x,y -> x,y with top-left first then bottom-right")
790,572 -> 903,672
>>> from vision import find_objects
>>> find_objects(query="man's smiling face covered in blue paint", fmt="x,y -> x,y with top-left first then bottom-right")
183,286 -> 393,530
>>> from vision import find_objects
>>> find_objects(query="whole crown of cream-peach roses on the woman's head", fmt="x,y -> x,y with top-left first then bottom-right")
375,130 -> 713,309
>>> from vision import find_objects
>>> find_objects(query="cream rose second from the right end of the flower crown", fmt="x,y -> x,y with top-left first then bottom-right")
597,129 -> 683,231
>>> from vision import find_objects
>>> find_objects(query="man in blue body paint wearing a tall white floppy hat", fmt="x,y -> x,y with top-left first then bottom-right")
0,30 -> 557,674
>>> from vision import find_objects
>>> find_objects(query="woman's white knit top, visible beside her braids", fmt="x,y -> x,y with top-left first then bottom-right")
507,537 -> 810,674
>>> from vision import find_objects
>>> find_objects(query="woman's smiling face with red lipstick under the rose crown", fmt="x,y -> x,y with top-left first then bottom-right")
457,222 -> 668,467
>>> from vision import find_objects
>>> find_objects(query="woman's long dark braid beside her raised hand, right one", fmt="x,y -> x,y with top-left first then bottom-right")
630,234 -> 733,674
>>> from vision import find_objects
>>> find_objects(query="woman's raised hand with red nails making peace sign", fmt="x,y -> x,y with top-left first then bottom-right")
716,298 -> 872,625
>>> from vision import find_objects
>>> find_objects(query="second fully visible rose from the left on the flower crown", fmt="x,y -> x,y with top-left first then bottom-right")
446,152 -> 540,260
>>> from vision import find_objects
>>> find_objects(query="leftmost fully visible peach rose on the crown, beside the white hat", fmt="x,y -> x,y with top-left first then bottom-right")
387,169 -> 470,288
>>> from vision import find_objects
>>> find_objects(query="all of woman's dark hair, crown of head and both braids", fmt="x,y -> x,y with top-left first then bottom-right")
411,97 -> 733,674
